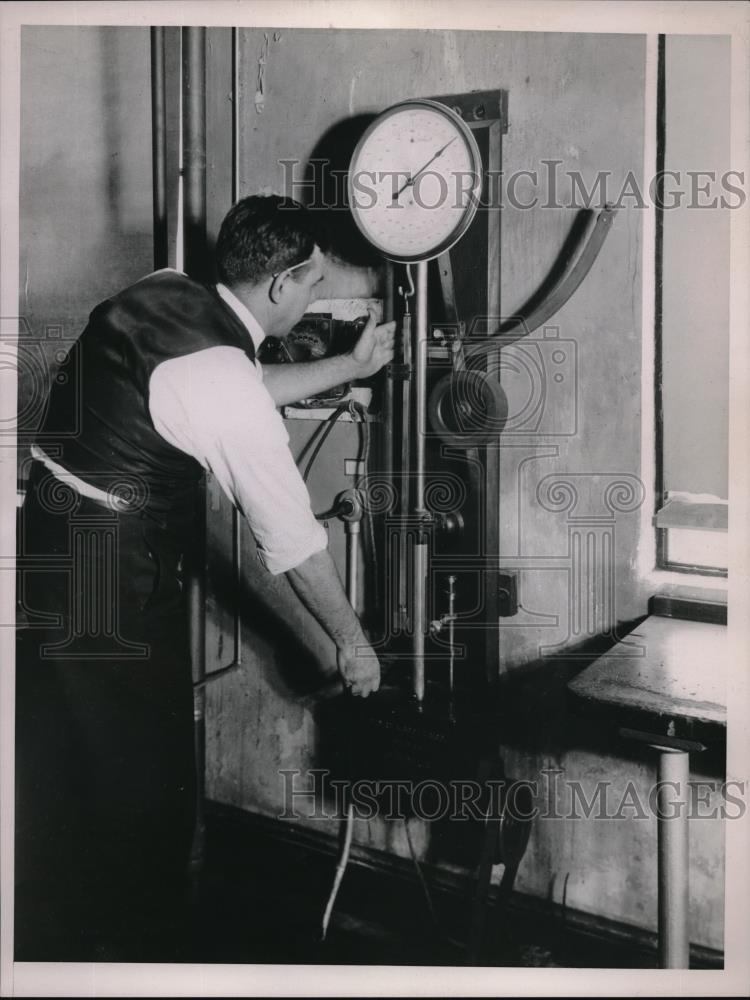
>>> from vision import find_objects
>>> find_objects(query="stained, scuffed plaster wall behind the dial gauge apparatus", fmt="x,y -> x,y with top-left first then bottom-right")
208,28 -> 723,947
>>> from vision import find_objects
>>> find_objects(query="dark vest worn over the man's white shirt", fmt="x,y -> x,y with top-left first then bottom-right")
39,271 -> 255,521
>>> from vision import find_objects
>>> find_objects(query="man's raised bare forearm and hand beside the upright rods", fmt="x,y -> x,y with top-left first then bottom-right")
263,310 -> 396,406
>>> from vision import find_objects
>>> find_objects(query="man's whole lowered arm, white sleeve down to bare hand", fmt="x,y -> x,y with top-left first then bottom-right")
149,347 -> 379,695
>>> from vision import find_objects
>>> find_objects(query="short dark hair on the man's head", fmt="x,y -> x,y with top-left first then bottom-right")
216,195 -> 326,286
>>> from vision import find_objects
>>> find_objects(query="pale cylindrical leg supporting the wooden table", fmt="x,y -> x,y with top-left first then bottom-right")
657,747 -> 690,969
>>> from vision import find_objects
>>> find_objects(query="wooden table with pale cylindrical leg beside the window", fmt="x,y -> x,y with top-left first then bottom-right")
569,615 -> 727,969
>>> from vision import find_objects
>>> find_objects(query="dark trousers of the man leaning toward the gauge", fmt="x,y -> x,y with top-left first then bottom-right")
15,466 -> 195,961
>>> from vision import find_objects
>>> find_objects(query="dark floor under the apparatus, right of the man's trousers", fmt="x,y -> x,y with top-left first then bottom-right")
191,815 -> 668,968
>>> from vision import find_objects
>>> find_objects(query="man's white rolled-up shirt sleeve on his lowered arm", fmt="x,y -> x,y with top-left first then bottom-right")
149,347 -> 328,574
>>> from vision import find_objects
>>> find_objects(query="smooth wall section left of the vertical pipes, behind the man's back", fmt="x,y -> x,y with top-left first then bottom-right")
19,27 -> 153,450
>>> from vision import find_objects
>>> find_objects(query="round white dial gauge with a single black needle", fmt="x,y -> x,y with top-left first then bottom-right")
349,101 -> 482,261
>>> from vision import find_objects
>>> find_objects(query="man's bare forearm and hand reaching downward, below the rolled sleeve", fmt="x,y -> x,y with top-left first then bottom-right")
286,549 -> 380,698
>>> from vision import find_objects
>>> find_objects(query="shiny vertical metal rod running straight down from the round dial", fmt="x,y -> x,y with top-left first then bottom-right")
412,261 -> 427,703
